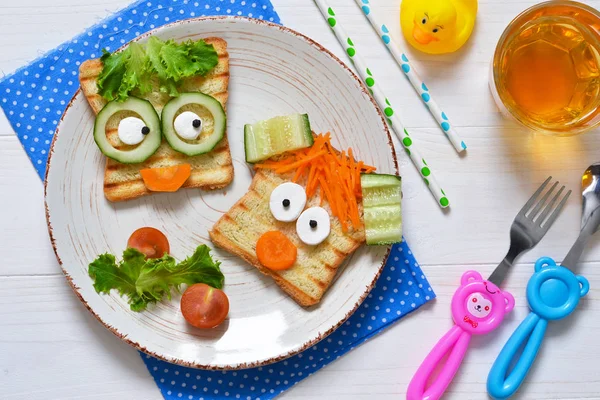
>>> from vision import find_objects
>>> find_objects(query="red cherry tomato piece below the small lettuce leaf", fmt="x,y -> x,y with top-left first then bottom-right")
181,283 -> 229,329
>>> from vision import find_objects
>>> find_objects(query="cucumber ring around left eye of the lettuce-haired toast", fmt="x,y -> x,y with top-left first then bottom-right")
94,96 -> 162,164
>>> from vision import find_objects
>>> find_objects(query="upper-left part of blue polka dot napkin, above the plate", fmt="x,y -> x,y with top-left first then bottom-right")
0,0 -> 280,179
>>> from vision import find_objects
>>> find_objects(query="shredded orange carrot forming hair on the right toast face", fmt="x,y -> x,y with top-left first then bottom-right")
254,132 -> 375,232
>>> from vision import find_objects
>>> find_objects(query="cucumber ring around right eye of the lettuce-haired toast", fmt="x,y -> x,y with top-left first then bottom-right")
161,92 -> 227,156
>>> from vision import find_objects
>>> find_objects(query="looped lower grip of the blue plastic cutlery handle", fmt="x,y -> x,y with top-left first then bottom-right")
487,313 -> 548,400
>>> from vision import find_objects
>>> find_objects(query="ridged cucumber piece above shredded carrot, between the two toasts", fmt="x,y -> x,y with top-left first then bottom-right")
244,114 -> 314,163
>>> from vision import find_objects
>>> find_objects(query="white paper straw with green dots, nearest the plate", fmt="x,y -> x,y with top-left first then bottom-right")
315,0 -> 450,208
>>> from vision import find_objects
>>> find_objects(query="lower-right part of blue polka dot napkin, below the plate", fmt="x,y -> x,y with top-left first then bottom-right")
142,241 -> 435,400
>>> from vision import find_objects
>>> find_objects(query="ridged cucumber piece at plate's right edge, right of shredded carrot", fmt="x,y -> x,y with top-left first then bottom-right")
360,174 -> 402,246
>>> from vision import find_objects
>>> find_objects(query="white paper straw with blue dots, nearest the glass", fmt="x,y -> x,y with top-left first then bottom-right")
355,0 -> 467,153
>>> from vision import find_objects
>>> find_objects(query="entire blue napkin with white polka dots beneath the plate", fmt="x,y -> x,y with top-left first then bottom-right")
0,0 -> 435,400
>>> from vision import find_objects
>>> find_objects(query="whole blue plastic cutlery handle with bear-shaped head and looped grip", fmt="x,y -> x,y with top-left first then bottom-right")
487,257 -> 590,399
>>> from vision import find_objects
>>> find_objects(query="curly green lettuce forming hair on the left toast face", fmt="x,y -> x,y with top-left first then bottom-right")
97,36 -> 219,101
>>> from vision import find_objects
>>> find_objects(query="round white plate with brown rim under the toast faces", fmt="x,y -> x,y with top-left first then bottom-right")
46,17 -> 397,369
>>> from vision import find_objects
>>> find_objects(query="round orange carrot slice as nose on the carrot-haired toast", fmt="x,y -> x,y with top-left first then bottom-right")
256,231 -> 298,271
